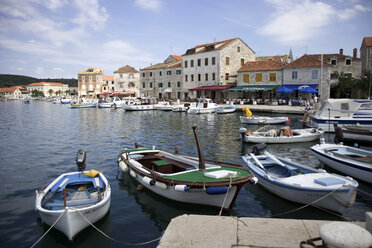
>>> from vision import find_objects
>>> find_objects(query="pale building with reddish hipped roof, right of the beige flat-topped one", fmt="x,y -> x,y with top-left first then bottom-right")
111,65 -> 140,97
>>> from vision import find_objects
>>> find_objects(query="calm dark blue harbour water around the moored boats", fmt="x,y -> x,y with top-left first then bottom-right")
0,101 -> 372,248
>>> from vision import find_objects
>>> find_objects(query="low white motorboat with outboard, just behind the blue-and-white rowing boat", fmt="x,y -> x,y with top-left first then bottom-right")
239,128 -> 324,144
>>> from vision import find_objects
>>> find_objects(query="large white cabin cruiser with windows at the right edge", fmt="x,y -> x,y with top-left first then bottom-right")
309,99 -> 372,132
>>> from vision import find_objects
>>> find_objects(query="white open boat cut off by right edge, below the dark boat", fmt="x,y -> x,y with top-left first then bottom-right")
311,143 -> 372,183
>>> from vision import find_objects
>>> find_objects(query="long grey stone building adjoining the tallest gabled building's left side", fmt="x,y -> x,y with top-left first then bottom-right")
140,55 -> 182,99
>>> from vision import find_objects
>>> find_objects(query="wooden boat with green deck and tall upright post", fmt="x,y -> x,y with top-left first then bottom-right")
118,127 -> 255,210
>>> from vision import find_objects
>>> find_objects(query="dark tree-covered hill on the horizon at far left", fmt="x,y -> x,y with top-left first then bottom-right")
0,74 -> 78,88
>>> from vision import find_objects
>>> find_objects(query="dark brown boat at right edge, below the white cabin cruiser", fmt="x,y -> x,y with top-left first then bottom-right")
341,125 -> 372,143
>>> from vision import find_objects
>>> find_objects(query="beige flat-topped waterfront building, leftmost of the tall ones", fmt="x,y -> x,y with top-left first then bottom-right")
78,68 -> 104,98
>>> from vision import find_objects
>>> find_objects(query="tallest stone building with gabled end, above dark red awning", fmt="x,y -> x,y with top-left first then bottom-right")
182,38 -> 255,99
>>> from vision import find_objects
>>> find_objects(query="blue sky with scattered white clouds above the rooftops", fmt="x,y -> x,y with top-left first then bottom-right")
0,0 -> 372,78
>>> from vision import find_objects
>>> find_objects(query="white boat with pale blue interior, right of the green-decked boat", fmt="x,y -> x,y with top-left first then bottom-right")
242,148 -> 358,213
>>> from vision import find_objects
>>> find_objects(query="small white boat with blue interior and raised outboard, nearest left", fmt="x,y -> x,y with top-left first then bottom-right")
35,150 -> 111,240
